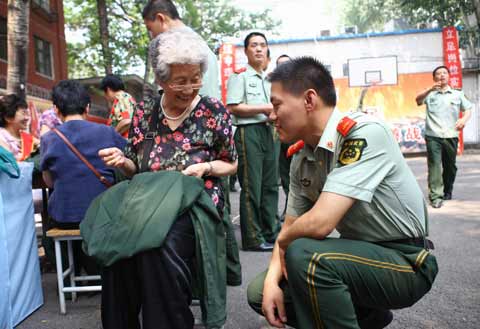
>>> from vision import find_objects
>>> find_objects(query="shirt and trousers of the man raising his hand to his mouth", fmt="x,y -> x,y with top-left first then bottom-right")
424,87 -> 472,202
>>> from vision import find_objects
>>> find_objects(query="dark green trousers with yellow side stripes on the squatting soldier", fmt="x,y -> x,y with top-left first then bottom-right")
247,238 -> 438,329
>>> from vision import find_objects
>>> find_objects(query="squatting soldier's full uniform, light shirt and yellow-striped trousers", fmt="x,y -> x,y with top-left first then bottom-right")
248,110 -> 438,329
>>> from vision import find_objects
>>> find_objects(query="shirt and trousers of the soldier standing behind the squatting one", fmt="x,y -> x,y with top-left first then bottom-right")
227,65 -> 279,249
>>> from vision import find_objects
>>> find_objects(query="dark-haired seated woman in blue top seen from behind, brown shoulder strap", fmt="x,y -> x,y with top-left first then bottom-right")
40,80 -> 125,273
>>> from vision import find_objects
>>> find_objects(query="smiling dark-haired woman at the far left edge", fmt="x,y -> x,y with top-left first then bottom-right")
0,94 -> 38,161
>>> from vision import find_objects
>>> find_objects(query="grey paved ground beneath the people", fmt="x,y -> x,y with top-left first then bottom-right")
17,152 -> 480,329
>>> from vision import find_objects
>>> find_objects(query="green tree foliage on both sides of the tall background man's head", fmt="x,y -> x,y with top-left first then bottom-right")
64,0 -> 280,78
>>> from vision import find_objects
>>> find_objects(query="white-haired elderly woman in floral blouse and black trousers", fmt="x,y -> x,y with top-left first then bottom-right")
100,30 -> 237,329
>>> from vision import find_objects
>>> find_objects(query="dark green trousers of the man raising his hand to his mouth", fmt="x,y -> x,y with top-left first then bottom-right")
426,136 -> 458,201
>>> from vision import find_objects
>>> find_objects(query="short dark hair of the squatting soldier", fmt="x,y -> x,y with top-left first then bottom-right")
269,56 -> 337,106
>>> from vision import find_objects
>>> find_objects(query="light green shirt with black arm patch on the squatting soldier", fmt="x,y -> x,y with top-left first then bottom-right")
287,110 -> 428,242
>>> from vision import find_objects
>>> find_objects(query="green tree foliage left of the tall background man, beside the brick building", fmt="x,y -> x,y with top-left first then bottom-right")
64,0 -> 148,78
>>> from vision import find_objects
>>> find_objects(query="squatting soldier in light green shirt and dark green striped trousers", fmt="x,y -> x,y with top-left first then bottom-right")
248,57 -> 438,329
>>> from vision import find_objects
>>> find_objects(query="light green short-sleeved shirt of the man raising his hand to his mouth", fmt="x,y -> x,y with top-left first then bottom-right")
423,86 -> 472,138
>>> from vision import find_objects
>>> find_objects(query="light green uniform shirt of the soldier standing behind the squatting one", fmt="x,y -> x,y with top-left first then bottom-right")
227,65 -> 272,126
